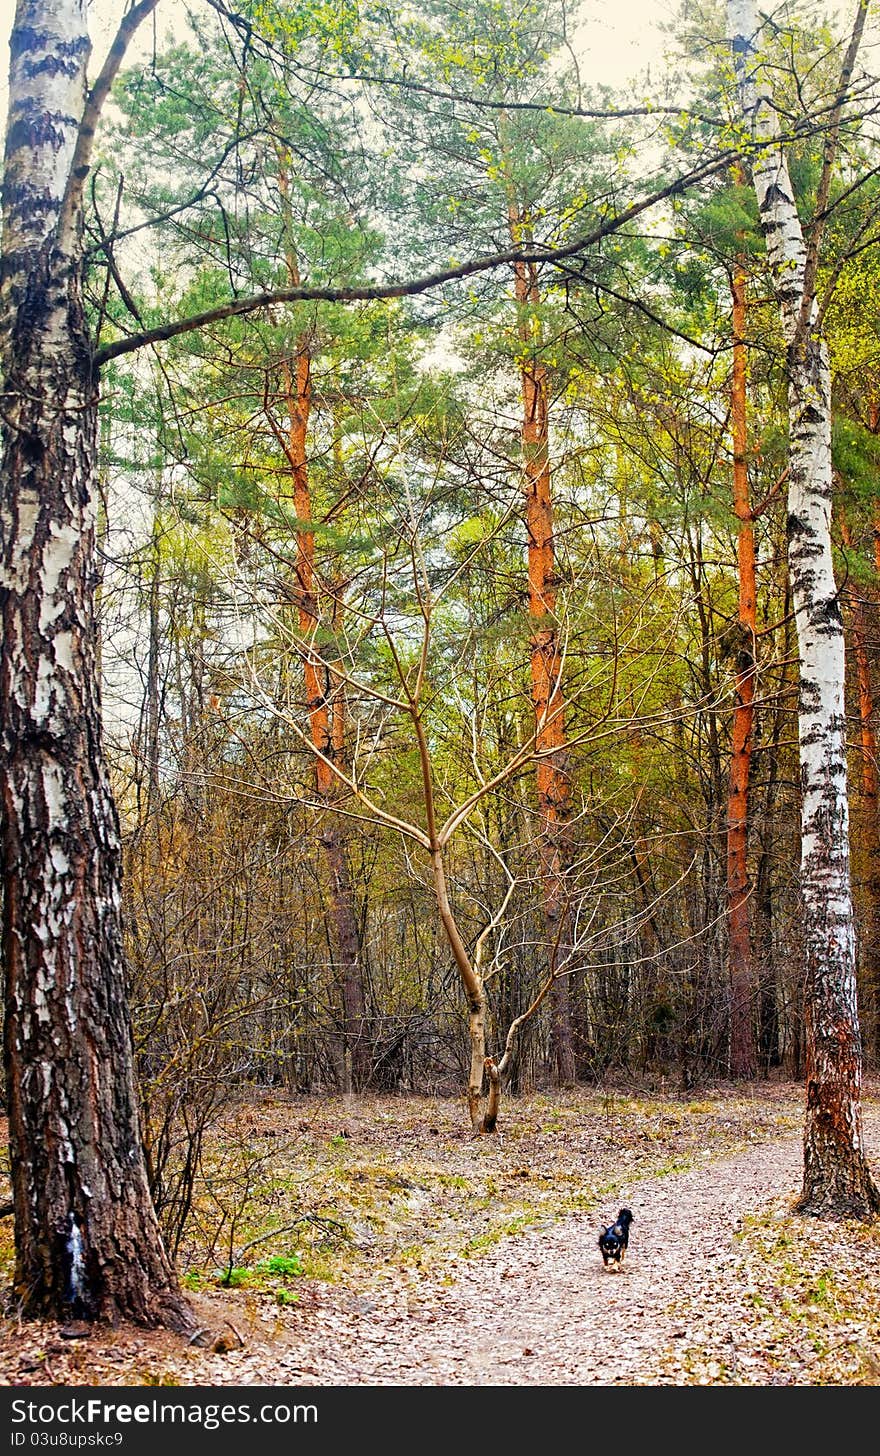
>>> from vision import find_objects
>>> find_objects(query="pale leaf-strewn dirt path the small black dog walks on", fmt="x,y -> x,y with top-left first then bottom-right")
269,1137 -> 801,1385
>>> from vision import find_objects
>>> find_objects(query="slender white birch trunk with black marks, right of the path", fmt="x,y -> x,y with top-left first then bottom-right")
727,0 -> 880,1217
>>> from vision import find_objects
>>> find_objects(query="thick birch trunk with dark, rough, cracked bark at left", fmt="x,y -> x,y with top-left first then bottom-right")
0,0 -> 191,1326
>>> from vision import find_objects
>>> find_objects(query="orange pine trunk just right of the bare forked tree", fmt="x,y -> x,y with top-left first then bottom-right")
510,221 -> 575,1085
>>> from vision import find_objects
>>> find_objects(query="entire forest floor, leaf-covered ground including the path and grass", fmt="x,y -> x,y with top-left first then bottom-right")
0,1082 -> 880,1386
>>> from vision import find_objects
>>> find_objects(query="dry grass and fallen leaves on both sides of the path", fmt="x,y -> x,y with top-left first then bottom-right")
0,1083 -> 880,1385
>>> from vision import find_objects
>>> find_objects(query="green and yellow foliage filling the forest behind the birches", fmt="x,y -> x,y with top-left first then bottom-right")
89,0 -> 880,1106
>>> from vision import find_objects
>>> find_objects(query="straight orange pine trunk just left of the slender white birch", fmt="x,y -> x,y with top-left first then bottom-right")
727,250 -> 758,1077
